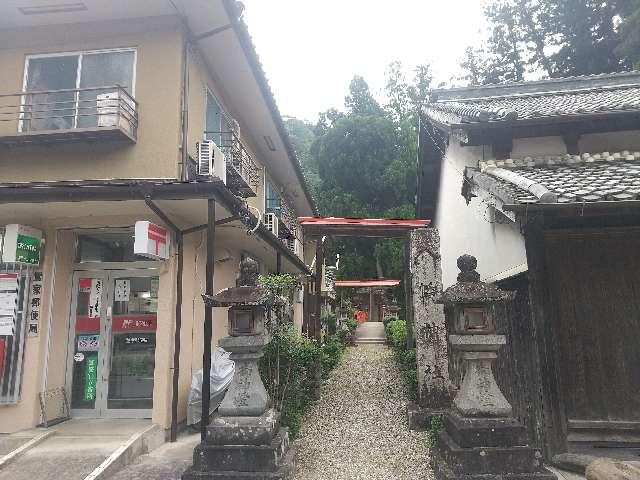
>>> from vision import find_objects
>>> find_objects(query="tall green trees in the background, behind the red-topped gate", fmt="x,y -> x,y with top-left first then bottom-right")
286,62 -> 431,312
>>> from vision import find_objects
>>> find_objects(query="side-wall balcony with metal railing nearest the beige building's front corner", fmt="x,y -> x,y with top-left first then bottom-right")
205,131 -> 261,198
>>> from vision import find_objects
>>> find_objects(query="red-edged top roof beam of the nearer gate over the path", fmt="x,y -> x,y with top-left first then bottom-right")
298,217 -> 431,238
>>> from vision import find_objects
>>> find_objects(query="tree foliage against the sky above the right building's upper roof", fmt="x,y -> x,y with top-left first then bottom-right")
461,0 -> 640,85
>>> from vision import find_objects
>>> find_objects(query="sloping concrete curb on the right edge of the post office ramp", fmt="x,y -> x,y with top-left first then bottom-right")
84,424 -> 165,480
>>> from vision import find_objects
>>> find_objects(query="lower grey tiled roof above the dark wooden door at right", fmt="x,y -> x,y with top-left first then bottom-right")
467,151 -> 640,204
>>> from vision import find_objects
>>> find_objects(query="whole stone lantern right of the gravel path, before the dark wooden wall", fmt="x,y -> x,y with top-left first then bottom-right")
433,255 -> 556,480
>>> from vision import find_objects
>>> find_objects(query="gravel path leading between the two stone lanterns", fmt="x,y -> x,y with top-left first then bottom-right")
295,345 -> 433,480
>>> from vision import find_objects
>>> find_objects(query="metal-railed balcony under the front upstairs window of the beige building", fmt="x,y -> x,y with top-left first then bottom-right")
0,85 -> 138,145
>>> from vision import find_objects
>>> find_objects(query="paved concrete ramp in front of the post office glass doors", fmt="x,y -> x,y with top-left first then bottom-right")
0,420 -> 150,480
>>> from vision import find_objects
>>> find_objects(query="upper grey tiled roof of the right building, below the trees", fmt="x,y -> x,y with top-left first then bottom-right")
423,73 -> 640,124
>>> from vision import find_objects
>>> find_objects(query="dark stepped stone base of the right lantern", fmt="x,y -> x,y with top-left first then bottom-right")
433,412 -> 556,480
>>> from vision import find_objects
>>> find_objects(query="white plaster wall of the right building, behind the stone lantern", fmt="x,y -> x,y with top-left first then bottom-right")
436,143 -> 526,288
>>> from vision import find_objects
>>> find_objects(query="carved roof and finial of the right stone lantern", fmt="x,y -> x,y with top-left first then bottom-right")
437,255 -> 513,305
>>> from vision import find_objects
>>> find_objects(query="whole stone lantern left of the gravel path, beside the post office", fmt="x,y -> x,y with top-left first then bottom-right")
182,258 -> 294,480
